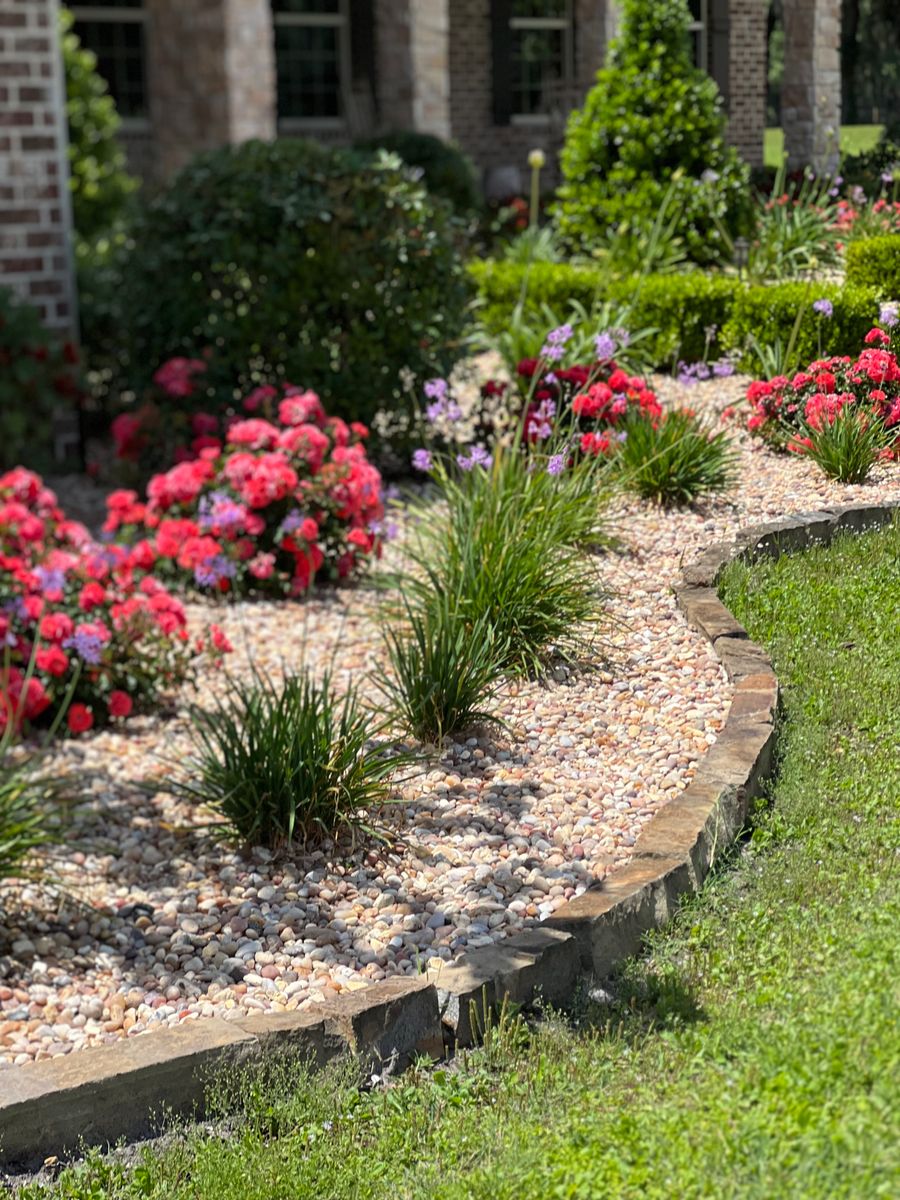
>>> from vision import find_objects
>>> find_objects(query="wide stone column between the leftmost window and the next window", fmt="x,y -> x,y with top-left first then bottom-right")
146,0 -> 275,179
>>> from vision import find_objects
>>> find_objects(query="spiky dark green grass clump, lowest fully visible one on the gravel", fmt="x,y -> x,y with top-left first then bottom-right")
173,673 -> 413,850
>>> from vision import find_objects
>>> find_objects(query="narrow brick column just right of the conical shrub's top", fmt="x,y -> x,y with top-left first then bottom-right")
727,0 -> 768,167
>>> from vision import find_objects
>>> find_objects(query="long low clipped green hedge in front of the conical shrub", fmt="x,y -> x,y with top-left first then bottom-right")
470,262 -> 888,370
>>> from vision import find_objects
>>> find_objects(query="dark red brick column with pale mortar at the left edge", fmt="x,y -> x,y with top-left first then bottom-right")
0,0 -> 76,335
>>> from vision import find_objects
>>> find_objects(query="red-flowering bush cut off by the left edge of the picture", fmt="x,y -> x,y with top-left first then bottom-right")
0,467 -> 230,733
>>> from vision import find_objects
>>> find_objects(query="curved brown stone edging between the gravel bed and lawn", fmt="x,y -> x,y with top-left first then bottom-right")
0,500 -> 900,1169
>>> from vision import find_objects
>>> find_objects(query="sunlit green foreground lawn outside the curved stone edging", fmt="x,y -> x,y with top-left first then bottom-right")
15,524 -> 900,1200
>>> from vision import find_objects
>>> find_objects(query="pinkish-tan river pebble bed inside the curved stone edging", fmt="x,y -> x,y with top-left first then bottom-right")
0,378 -> 900,1067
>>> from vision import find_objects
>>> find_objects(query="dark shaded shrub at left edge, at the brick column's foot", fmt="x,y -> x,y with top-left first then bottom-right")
0,288 -> 82,469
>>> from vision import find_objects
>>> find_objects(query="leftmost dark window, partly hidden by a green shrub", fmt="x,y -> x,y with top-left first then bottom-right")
72,0 -> 148,121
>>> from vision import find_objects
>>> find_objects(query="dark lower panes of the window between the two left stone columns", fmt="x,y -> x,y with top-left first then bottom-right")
275,25 -> 341,119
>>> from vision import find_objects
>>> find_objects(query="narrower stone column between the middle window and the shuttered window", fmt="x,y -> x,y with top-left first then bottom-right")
376,0 -> 450,138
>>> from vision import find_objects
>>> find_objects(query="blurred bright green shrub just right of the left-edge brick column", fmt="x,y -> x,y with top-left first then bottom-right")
60,8 -> 138,239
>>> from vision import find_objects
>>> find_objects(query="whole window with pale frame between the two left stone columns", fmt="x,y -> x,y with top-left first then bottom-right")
272,0 -> 349,125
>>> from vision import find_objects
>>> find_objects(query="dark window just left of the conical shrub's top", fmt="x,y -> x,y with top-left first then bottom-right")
509,0 -> 574,120
